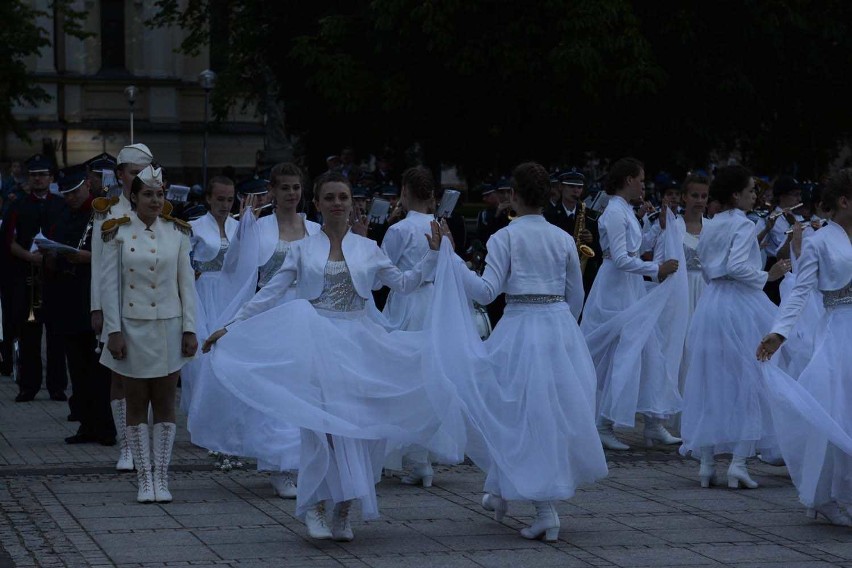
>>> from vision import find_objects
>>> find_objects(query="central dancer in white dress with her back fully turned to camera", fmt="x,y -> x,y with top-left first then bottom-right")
432,163 -> 607,541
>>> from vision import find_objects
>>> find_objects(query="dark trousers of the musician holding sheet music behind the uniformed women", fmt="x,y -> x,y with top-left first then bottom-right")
63,331 -> 115,437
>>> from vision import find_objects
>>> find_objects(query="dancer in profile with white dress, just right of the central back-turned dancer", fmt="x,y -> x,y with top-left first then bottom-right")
580,158 -> 687,450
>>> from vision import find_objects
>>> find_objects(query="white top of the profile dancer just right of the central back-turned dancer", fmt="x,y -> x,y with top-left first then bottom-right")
598,195 -> 660,277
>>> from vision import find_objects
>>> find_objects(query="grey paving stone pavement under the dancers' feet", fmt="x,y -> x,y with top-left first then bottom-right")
0,377 -> 852,568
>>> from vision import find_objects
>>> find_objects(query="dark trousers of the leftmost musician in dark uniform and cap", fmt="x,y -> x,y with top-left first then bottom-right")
18,318 -> 68,395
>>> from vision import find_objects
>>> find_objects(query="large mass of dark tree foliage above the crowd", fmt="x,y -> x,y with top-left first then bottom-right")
151,0 -> 852,175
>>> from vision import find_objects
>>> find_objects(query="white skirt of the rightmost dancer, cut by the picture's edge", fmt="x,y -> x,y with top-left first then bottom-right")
763,305 -> 852,507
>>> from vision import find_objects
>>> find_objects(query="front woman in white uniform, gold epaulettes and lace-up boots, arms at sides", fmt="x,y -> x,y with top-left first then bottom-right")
101,166 -> 198,503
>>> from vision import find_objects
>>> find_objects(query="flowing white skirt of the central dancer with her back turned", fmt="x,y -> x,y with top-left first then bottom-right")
430,250 -> 607,501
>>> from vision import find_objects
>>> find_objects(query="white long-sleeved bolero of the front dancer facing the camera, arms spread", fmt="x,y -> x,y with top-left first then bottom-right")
231,231 -> 438,323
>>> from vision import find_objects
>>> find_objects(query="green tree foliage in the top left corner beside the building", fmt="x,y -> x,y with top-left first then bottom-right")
0,0 -> 89,139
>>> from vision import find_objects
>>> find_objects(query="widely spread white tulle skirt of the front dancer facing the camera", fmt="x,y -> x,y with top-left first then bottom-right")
205,300 -> 465,519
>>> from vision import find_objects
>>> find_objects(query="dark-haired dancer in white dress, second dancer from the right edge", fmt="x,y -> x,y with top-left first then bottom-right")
681,166 -> 789,489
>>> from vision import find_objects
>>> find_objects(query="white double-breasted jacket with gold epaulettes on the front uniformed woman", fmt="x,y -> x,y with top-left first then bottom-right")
102,213 -> 195,334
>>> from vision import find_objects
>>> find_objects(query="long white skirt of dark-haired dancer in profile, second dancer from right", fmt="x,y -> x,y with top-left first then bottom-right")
681,279 -> 783,457
